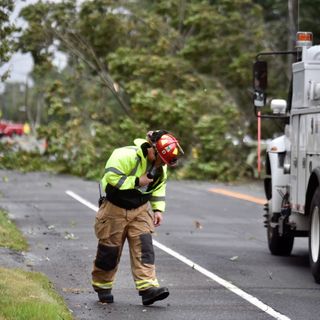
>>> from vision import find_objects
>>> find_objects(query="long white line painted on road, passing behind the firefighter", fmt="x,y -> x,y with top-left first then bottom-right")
66,190 -> 290,320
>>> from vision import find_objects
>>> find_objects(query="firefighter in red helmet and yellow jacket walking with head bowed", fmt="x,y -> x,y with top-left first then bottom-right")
92,130 -> 183,305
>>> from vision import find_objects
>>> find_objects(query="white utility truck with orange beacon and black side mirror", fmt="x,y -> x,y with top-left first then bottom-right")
253,32 -> 320,283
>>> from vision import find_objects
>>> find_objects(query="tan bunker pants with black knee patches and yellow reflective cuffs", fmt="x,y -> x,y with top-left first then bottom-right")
92,201 -> 159,291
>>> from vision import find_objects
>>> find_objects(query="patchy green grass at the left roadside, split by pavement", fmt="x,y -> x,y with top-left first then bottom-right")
0,208 -> 73,320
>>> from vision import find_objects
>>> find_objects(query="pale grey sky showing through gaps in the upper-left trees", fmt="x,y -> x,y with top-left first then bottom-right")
0,0 -> 66,92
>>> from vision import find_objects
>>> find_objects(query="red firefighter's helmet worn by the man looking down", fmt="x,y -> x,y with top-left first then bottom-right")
154,133 -> 183,167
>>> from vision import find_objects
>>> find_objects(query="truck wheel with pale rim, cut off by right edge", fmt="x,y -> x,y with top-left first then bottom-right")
309,187 -> 320,283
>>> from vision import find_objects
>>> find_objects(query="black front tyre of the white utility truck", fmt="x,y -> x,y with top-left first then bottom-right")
267,215 -> 294,256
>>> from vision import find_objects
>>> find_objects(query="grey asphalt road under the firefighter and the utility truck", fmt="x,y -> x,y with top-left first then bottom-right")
0,171 -> 320,320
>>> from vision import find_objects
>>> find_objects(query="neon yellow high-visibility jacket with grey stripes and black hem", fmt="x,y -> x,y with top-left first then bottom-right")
101,139 -> 167,212
